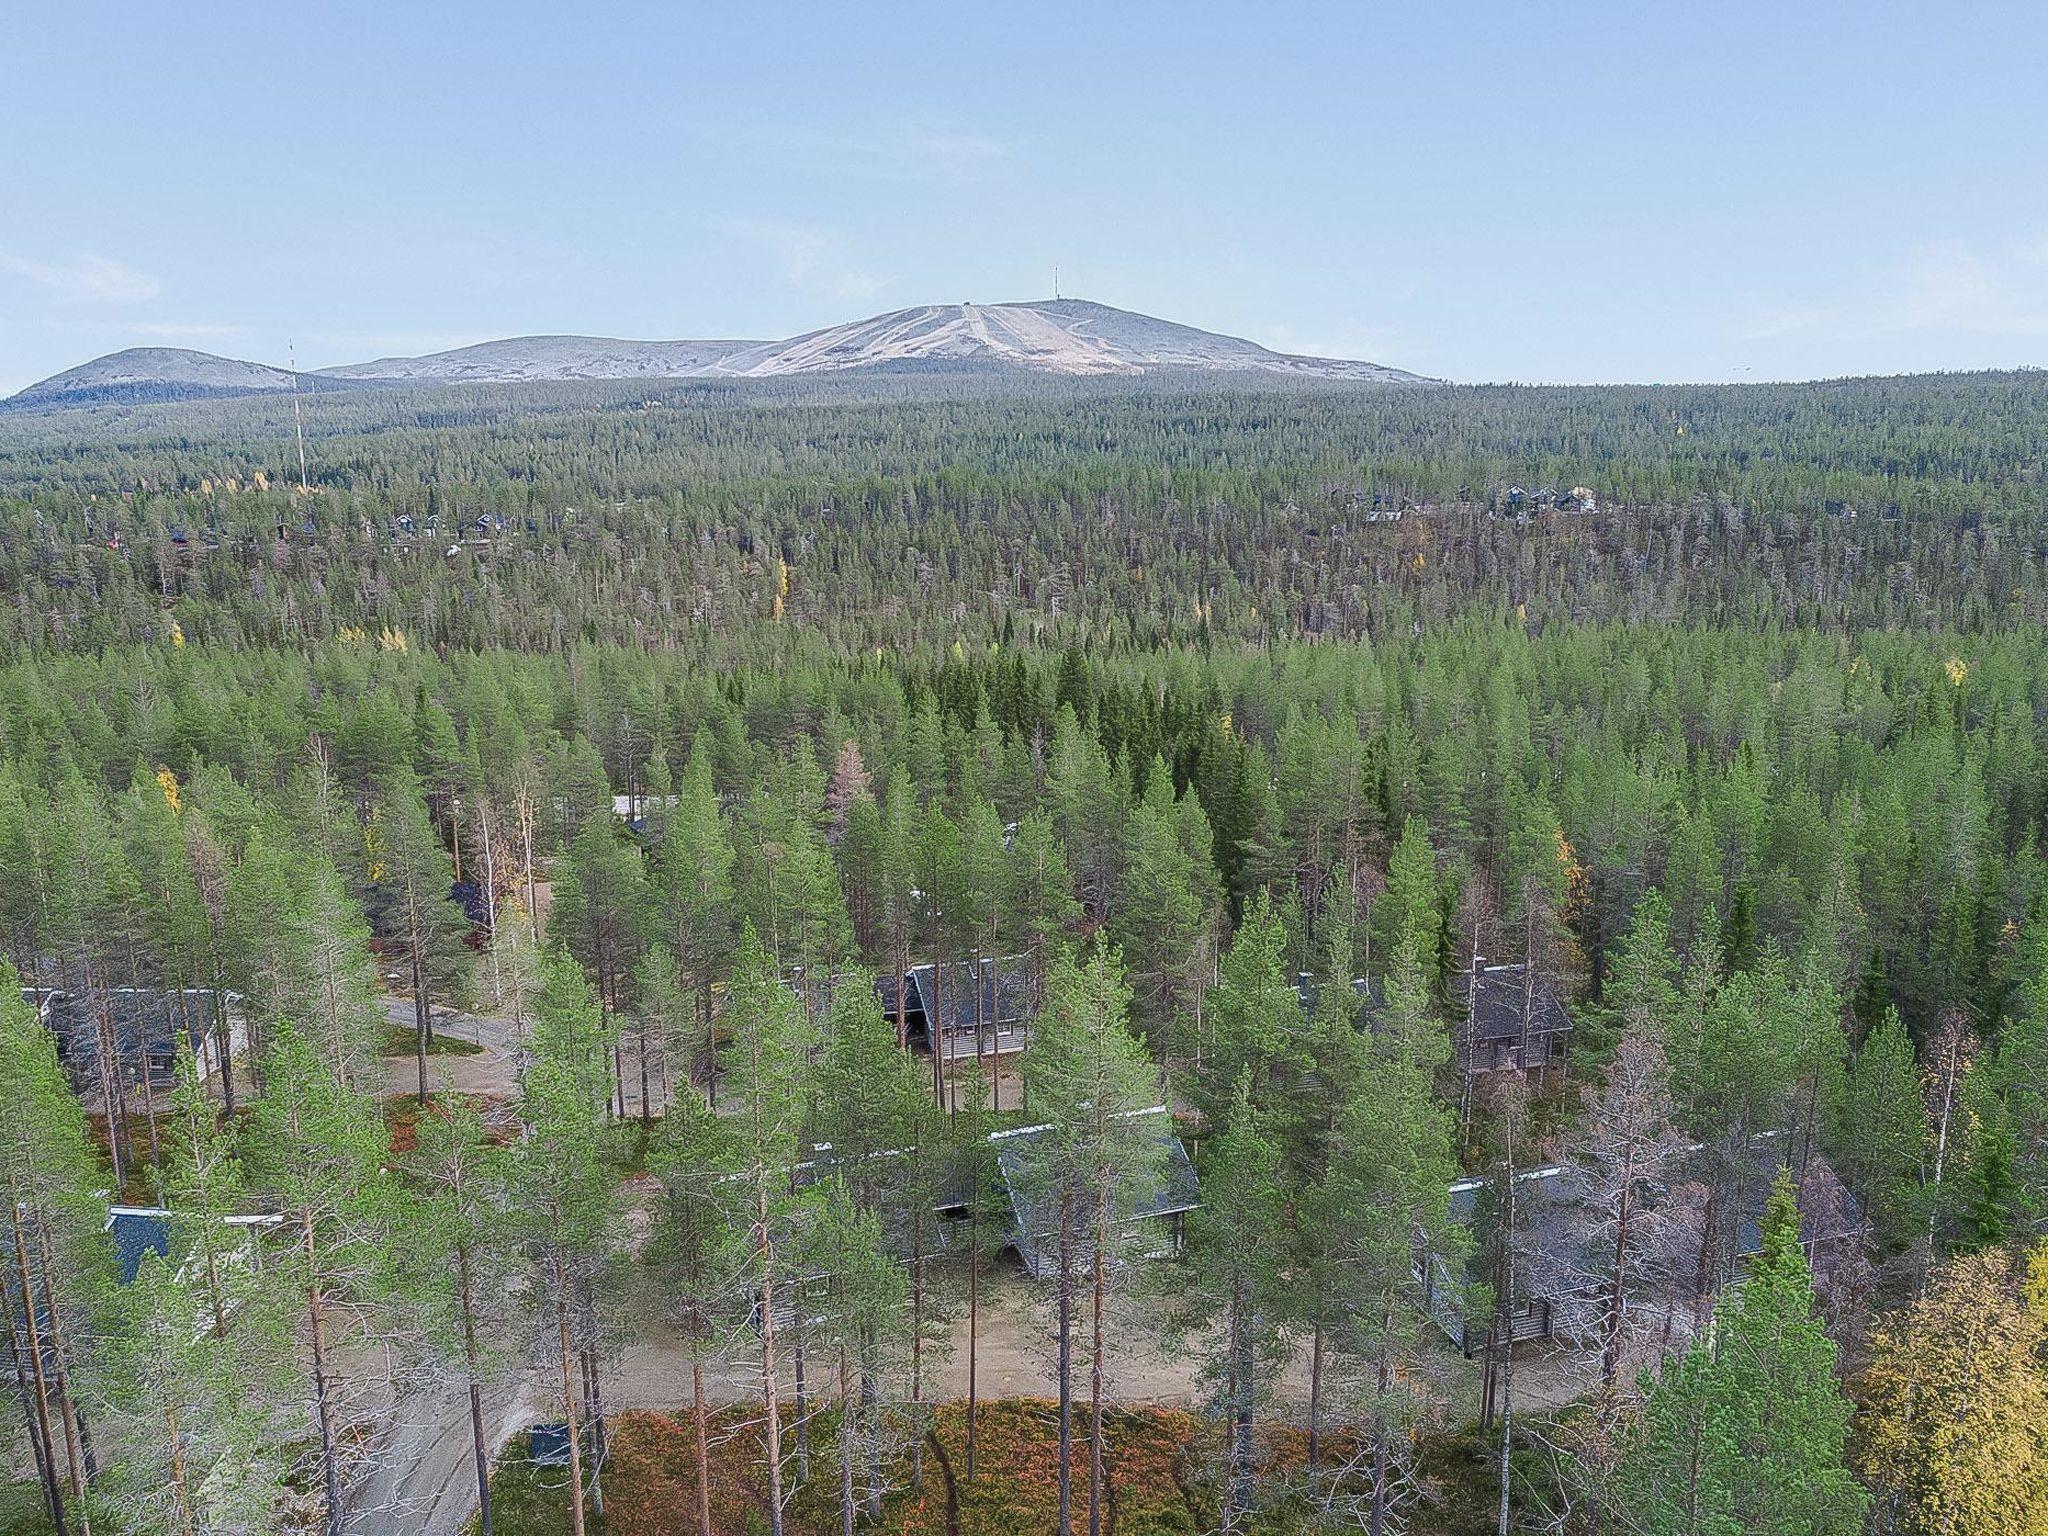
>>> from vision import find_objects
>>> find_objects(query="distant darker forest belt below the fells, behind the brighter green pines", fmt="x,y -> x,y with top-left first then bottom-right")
0,375 -> 2048,647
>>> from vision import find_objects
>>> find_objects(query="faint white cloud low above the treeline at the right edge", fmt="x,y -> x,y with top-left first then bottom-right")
1749,236 -> 2048,340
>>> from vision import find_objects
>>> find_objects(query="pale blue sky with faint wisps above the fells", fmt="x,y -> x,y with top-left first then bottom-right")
0,0 -> 2048,391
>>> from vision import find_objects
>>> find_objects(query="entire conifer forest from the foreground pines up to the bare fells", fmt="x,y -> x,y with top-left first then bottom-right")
0,375 -> 2048,1536
